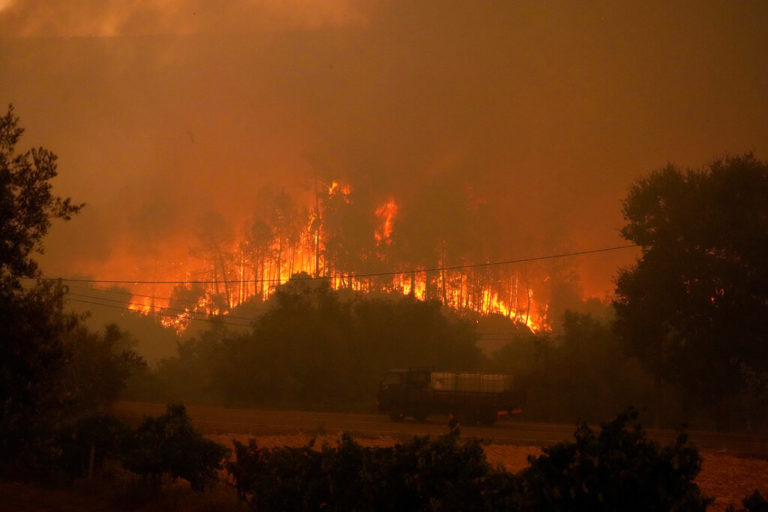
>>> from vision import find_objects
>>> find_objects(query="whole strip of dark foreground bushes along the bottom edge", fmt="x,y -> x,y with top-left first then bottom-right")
9,405 -> 768,512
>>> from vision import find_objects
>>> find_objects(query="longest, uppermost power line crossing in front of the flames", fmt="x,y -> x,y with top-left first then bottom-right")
45,244 -> 640,285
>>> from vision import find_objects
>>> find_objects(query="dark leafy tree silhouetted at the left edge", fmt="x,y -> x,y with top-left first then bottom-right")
0,107 -> 82,459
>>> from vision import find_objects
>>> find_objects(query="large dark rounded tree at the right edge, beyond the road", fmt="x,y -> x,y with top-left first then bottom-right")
615,154 -> 768,403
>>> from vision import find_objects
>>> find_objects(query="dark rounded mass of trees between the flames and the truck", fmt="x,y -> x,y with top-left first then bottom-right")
148,276 -> 481,410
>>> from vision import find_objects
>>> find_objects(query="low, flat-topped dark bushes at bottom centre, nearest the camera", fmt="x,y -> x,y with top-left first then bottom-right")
227,434 -> 488,511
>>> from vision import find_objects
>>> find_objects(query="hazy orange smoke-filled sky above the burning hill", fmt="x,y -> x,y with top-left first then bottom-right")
0,0 -> 768,291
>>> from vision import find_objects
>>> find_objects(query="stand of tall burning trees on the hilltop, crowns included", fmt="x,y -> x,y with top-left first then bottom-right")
124,176 -> 546,328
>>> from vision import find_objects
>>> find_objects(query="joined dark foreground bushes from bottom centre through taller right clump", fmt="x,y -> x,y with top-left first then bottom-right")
226,410 -> 711,512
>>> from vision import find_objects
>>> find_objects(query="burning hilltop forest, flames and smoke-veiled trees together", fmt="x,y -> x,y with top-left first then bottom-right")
109,180 -> 548,331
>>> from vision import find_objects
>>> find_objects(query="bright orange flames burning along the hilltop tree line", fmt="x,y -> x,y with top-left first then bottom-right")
91,181 -> 549,332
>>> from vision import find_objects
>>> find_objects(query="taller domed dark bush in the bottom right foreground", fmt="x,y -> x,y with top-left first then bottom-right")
512,409 -> 711,512
